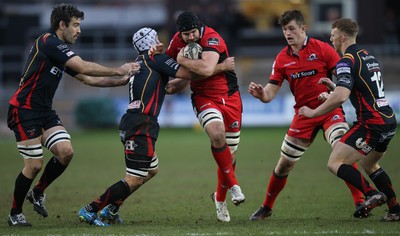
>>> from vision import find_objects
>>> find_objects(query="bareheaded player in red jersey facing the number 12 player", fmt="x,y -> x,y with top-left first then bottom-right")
248,10 -> 365,220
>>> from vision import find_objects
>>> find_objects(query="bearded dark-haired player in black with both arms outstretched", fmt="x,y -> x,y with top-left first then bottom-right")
7,4 -> 140,226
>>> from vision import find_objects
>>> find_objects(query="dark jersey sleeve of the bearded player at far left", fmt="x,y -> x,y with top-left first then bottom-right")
41,34 -> 76,64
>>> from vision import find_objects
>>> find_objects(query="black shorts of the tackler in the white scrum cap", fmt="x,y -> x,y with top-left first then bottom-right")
119,112 -> 160,162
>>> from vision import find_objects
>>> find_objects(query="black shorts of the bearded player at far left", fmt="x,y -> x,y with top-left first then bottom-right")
7,105 -> 63,142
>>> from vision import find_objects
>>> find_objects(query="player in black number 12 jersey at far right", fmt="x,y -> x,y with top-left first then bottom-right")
299,18 -> 400,221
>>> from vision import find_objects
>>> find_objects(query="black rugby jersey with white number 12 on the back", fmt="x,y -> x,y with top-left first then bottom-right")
336,44 -> 396,125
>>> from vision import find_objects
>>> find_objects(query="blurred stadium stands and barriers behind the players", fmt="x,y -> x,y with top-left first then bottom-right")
0,0 -> 400,137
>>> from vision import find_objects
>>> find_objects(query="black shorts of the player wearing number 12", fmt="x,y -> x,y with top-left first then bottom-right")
340,122 -> 396,155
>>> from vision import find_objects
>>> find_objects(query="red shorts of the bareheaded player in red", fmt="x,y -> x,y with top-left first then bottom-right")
287,108 -> 346,140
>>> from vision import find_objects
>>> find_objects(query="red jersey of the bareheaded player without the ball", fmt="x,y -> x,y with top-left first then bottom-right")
268,37 -> 340,110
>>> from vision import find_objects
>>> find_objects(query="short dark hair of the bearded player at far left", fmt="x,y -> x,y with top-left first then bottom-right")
50,3 -> 84,31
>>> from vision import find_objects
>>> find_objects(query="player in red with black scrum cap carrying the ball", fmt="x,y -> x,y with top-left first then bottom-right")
162,12 -> 245,222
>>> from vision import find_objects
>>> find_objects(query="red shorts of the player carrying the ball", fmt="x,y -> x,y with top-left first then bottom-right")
192,91 -> 243,132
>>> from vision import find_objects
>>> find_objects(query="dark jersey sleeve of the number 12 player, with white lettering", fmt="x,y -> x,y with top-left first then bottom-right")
336,56 -> 354,90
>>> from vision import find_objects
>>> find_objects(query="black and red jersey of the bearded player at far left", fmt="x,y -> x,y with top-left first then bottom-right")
10,33 -> 77,111
